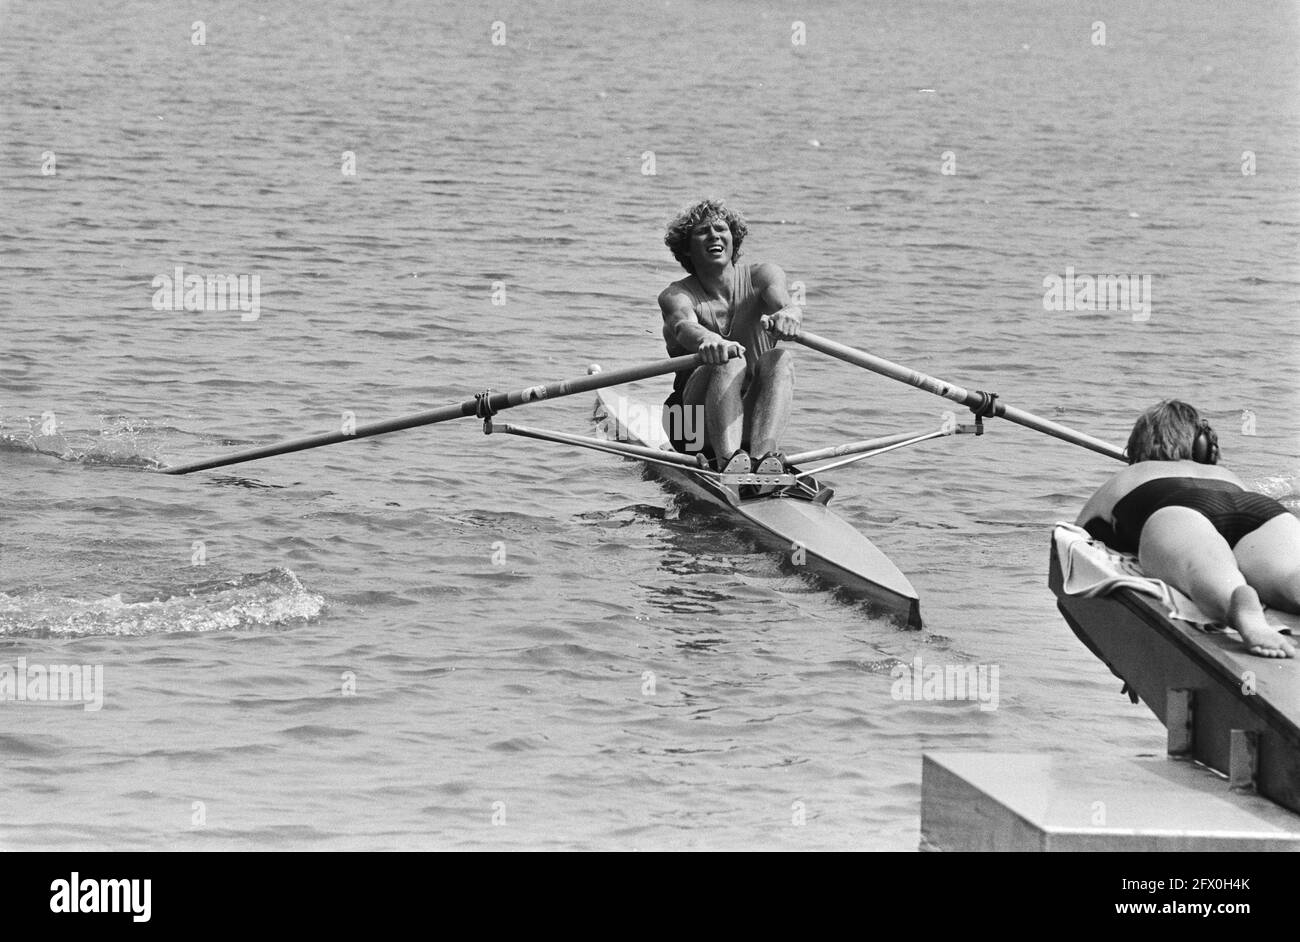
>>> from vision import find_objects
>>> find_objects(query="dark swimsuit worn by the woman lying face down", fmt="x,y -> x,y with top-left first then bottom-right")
1106,478 -> 1288,554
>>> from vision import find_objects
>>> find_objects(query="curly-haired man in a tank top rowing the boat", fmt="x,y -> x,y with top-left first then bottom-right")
659,200 -> 803,474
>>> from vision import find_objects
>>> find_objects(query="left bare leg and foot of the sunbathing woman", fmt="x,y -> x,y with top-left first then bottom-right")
1138,507 -> 1295,657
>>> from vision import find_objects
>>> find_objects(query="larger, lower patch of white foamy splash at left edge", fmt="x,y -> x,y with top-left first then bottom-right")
0,568 -> 325,638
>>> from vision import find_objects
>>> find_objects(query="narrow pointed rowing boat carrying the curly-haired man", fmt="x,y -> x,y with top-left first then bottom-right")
595,390 -> 920,628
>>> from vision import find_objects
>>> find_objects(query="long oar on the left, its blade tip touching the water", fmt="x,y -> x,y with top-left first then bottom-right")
163,353 -> 703,474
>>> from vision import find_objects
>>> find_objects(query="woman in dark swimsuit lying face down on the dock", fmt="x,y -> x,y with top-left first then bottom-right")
1076,399 -> 1300,657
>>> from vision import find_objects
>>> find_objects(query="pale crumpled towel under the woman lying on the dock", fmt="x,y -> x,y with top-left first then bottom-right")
1052,522 -> 1300,634
